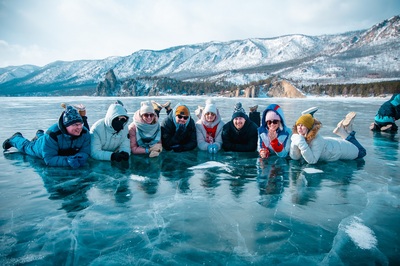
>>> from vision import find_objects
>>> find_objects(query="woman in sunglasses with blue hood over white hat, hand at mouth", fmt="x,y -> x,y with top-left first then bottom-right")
258,104 -> 291,158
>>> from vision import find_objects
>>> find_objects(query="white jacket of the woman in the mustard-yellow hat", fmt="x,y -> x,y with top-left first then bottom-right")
290,119 -> 359,164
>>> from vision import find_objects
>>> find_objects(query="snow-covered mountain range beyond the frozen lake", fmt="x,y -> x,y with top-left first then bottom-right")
0,16 -> 400,95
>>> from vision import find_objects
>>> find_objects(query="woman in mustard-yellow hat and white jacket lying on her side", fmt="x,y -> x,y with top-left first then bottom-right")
290,112 -> 367,164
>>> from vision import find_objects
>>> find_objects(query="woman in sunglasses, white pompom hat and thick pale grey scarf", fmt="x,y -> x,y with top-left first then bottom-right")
129,101 -> 162,157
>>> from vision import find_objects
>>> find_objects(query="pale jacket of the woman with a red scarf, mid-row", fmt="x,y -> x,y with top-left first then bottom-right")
196,110 -> 225,151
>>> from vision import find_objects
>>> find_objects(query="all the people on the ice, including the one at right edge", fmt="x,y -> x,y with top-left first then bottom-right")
3,94 -> 400,168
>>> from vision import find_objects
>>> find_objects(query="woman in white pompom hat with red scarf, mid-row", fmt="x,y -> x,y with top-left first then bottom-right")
196,99 -> 224,153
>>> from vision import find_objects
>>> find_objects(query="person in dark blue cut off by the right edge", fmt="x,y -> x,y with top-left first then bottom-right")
369,94 -> 400,132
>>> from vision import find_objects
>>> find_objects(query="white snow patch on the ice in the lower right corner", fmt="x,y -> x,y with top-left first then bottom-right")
345,217 -> 378,249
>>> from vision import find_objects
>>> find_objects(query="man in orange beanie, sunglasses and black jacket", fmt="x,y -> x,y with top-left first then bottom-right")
161,103 -> 197,152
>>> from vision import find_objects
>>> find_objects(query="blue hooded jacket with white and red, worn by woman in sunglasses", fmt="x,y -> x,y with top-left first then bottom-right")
258,104 -> 292,157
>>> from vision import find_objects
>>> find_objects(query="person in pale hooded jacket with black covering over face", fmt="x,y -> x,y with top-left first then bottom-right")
90,101 -> 131,162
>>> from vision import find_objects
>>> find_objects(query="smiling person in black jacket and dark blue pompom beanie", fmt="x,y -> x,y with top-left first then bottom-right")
222,103 -> 258,152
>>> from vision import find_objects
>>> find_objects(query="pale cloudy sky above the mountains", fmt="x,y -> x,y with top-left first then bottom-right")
0,0 -> 400,67
